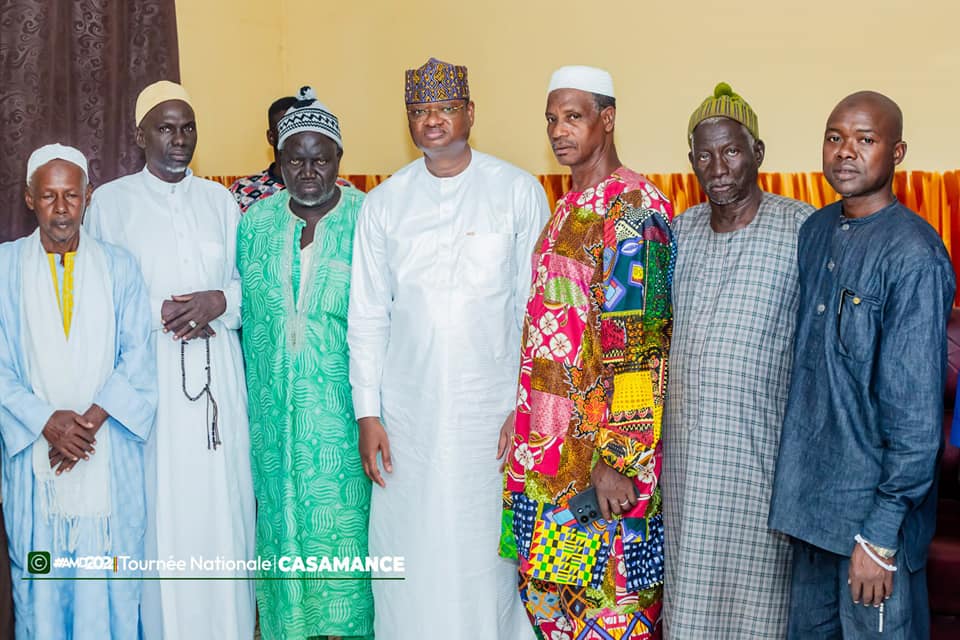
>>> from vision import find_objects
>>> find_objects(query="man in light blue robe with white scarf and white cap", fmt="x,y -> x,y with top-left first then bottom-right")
0,144 -> 157,640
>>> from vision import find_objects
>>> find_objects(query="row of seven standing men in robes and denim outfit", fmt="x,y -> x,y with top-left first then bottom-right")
0,59 -> 955,640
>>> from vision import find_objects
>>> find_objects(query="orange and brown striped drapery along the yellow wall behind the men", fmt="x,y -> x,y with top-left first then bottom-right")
209,171 -> 960,305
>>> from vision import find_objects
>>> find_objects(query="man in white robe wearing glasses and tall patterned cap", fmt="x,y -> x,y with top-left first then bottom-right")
347,59 -> 550,640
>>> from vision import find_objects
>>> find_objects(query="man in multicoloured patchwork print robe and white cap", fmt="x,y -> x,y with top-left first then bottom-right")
501,67 -> 675,640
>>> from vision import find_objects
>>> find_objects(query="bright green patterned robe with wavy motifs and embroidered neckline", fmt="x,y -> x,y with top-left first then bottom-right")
237,187 -> 373,640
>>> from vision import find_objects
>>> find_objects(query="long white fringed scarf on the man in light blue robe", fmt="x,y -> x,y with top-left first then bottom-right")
20,230 -> 116,552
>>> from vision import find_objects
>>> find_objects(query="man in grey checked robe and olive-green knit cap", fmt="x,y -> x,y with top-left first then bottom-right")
662,82 -> 813,640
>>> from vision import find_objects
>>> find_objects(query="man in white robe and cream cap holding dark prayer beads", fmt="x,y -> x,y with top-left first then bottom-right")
85,81 -> 255,640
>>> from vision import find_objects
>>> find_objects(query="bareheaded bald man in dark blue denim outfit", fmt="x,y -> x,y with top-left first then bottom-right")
769,91 -> 955,640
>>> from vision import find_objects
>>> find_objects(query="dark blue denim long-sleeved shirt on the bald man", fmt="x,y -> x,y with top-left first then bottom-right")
770,202 -> 955,569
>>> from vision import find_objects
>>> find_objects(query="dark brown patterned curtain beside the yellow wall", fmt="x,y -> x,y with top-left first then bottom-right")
0,0 -> 180,241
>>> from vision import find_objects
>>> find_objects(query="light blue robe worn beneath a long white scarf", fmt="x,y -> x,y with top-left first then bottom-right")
0,236 -> 157,640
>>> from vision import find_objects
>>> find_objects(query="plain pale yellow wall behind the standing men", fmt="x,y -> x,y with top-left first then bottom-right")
177,0 -> 960,179
